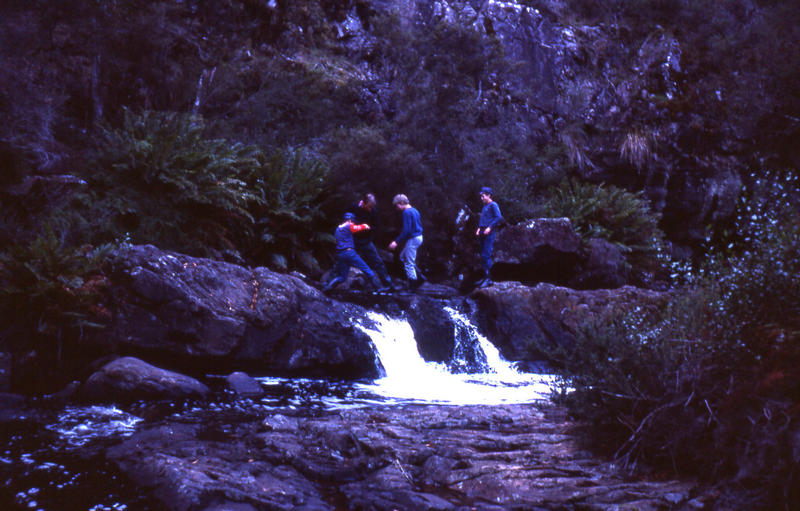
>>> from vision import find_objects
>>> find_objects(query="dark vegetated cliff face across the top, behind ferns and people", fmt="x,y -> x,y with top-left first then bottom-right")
0,0 -> 800,271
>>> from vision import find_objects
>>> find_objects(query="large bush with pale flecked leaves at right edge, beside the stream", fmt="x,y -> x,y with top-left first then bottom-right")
557,174 -> 800,509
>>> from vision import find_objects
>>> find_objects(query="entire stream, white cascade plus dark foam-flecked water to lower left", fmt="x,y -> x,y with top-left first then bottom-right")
0,309 -> 553,511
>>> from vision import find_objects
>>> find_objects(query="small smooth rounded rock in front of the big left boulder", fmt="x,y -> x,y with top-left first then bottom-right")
81,357 -> 209,401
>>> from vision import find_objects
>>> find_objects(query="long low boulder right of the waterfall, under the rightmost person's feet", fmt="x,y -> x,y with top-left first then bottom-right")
471,282 -> 669,361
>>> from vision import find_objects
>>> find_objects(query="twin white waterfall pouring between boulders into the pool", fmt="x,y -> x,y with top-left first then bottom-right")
359,308 -> 553,405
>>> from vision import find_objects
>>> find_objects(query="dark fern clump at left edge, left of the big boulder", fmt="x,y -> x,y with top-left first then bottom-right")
0,229 -> 107,363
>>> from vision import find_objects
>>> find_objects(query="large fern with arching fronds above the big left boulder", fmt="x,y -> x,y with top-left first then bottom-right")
83,110 -> 259,255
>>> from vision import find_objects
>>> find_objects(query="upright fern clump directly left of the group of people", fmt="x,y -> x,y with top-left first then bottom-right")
248,148 -> 332,272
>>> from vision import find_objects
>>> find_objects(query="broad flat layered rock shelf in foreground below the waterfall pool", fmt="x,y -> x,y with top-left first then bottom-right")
107,405 -> 697,511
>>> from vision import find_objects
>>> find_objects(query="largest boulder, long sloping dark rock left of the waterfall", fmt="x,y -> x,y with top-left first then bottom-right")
103,245 -> 379,378
